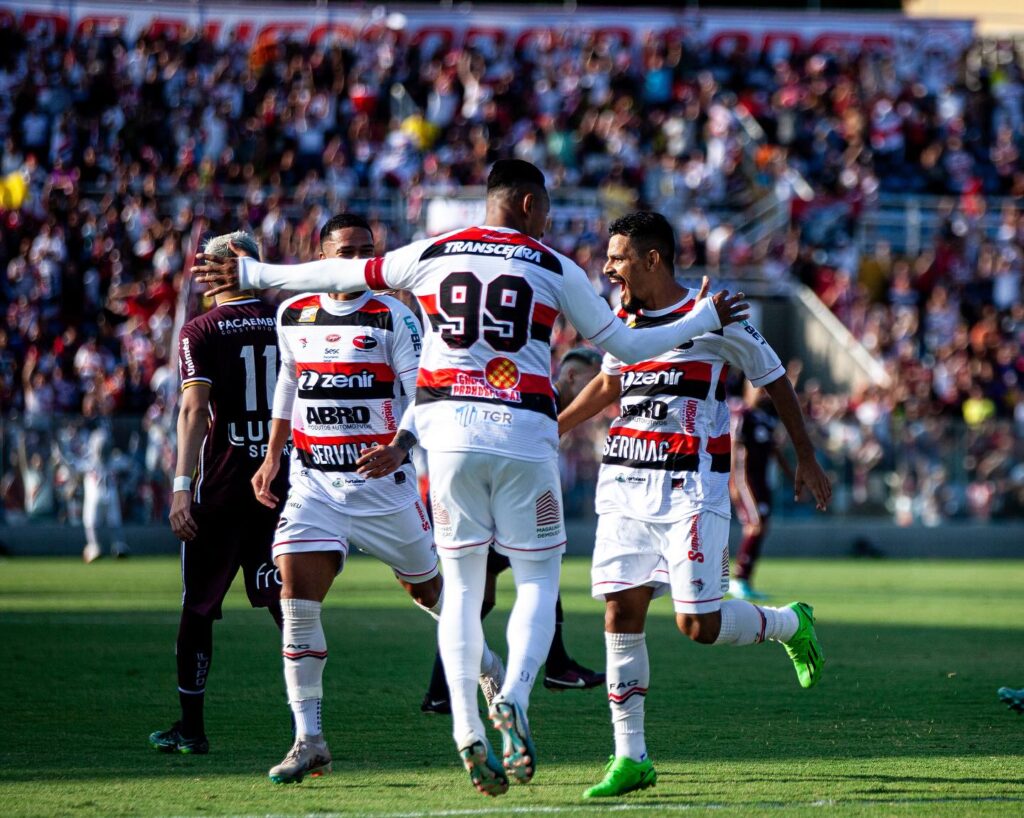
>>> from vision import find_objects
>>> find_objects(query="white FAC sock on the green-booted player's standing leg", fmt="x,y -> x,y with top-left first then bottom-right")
604,633 -> 650,762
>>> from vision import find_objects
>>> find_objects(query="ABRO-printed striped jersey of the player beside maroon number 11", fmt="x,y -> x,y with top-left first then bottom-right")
273,293 -> 422,516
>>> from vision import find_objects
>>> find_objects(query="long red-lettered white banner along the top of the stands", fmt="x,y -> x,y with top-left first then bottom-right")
0,0 -> 974,70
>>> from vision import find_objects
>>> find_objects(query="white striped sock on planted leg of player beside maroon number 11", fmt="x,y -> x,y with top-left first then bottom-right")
281,599 -> 327,738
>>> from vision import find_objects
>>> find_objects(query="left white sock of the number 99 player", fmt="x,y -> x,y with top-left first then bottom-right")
437,553 -> 487,748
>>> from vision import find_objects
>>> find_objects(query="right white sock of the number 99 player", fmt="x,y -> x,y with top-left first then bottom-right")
499,554 -> 562,711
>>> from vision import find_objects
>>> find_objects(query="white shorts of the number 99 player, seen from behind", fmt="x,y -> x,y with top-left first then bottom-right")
427,450 -> 565,559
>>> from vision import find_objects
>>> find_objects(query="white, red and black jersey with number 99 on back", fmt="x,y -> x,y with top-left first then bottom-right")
367,227 -> 614,461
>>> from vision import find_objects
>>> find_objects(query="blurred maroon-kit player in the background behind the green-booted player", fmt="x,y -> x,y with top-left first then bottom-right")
729,383 -> 796,602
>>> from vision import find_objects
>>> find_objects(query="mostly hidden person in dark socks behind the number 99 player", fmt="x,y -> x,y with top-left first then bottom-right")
420,347 -> 604,714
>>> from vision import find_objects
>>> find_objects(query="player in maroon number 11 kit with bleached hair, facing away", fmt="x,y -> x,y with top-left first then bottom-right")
150,231 -> 288,754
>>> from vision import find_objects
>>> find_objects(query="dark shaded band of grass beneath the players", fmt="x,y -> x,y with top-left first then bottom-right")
0,606 -> 1024,795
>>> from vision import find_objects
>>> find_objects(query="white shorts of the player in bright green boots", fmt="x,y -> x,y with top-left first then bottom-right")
591,512 -> 729,613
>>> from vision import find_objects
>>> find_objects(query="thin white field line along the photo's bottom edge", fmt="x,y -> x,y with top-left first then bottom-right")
153,797 -> 1024,818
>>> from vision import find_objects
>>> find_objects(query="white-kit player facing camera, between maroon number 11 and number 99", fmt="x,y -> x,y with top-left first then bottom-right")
252,214 -> 503,783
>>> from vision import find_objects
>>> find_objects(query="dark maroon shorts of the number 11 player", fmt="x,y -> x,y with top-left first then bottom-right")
181,504 -> 281,619
